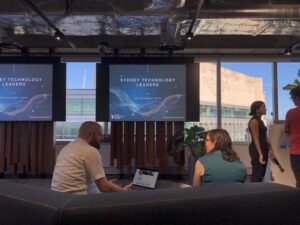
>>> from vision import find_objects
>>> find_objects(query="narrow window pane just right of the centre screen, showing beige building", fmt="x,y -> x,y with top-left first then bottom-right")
185,62 -> 217,130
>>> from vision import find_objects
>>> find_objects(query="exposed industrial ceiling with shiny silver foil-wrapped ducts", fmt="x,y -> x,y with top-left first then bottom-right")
0,0 -> 300,54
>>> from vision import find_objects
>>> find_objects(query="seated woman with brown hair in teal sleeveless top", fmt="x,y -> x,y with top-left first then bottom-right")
193,129 -> 246,186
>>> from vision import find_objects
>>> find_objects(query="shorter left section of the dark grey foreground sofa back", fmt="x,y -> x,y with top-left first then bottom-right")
0,180 -> 74,225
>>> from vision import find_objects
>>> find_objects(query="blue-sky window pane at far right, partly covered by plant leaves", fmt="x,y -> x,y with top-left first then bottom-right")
277,62 -> 300,120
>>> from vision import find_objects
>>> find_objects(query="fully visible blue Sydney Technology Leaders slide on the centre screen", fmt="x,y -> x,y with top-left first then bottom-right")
109,64 -> 186,121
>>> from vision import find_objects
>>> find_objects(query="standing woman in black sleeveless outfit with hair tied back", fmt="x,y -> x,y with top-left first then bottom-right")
248,101 -> 275,182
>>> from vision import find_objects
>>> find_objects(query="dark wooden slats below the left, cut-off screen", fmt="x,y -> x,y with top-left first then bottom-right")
0,122 -> 55,175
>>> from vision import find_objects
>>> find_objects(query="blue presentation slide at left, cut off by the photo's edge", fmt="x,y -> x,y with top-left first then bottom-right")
0,64 -> 53,121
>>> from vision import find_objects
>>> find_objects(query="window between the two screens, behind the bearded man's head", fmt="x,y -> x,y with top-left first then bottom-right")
56,63 -> 97,140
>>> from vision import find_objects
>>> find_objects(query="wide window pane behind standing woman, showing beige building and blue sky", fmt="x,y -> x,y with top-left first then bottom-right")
221,62 -> 273,142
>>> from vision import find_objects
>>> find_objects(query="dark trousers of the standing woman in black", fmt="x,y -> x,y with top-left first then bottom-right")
249,145 -> 268,182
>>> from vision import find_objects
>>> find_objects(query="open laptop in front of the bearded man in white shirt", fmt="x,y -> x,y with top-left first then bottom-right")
132,168 -> 159,190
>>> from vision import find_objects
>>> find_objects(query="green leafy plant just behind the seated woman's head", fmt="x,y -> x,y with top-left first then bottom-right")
172,125 -> 206,182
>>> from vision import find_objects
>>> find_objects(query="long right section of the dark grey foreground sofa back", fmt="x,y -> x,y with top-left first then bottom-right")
62,183 -> 300,225
